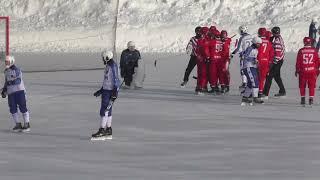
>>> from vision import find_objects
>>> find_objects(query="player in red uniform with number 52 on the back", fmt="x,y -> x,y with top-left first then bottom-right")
295,37 -> 319,106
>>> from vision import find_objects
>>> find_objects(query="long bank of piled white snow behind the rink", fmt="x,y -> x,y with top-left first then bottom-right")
0,0 -> 320,52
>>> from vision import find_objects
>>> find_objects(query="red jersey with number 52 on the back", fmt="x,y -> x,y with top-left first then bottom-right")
296,46 -> 319,74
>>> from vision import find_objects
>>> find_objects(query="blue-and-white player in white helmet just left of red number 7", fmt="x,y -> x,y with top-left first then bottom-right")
241,37 -> 263,106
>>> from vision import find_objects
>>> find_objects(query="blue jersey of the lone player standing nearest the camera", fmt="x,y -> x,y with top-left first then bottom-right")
102,60 -> 120,90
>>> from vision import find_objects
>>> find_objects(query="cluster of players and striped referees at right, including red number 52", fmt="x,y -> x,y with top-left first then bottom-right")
181,25 -> 319,105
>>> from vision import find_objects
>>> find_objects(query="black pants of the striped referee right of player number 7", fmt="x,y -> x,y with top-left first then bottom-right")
263,60 -> 286,96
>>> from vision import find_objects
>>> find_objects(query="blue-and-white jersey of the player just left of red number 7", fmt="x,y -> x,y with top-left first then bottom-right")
240,46 -> 258,69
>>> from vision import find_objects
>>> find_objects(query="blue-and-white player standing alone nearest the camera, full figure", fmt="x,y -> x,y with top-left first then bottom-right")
91,51 -> 120,140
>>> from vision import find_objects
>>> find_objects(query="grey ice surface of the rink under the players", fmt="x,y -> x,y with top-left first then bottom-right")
0,53 -> 320,180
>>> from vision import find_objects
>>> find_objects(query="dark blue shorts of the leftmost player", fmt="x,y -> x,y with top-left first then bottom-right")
8,91 -> 28,114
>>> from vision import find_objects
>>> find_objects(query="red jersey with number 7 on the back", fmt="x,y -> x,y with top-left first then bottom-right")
257,37 -> 274,63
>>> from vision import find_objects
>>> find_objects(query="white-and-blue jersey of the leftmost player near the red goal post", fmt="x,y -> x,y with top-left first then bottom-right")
4,65 -> 25,95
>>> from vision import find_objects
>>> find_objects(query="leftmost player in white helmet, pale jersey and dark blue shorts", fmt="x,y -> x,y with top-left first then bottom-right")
1,56 -> 30,132
